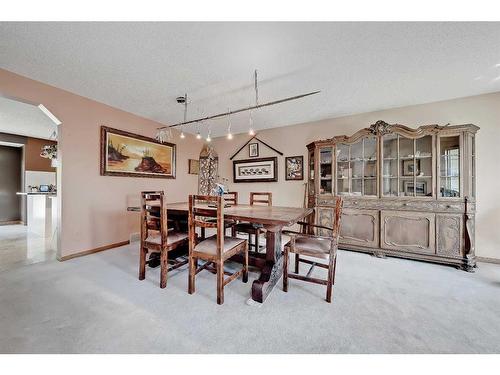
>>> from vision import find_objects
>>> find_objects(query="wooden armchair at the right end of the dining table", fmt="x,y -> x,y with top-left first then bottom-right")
283,197 -> 342,302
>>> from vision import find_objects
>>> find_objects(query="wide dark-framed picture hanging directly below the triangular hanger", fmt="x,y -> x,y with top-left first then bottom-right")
233,157 -> 278,182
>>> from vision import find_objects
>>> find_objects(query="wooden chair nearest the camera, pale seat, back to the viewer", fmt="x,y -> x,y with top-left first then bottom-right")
188,195 -> 248,305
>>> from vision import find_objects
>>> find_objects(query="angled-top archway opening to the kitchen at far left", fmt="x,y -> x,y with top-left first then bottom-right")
0,95 -> 61,272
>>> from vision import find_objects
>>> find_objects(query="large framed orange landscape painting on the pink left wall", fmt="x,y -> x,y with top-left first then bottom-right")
101,126 -> 176,178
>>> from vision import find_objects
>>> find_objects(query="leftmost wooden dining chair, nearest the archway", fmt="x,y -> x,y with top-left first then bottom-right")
139,191 -> 189,288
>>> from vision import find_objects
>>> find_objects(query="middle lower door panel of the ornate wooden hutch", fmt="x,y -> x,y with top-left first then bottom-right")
380,211 -> 436,254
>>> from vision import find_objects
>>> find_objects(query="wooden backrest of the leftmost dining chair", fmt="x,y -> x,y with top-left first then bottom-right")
141,191 -> 168,246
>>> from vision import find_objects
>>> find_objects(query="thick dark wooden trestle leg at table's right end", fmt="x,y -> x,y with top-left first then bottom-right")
252,228 -> 283,303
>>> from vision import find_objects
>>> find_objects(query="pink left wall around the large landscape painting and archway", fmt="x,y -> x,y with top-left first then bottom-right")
0,69 -> 201,256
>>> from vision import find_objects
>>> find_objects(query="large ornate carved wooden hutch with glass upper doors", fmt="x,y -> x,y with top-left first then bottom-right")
307,121 -> 479,271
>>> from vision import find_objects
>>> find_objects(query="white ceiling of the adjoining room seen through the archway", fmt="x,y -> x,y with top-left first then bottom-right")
0,97 -> 57,139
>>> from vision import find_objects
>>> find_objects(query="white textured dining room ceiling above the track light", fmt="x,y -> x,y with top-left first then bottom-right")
0,22 -> 500,136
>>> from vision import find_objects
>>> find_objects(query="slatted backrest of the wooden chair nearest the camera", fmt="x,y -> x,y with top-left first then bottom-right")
188,195 -> 224,258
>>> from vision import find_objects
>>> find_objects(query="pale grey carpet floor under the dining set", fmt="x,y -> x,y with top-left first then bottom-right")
0,243 -> 500,353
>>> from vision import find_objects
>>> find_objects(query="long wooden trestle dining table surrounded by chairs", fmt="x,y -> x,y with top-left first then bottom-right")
127,202 -> 313,303
